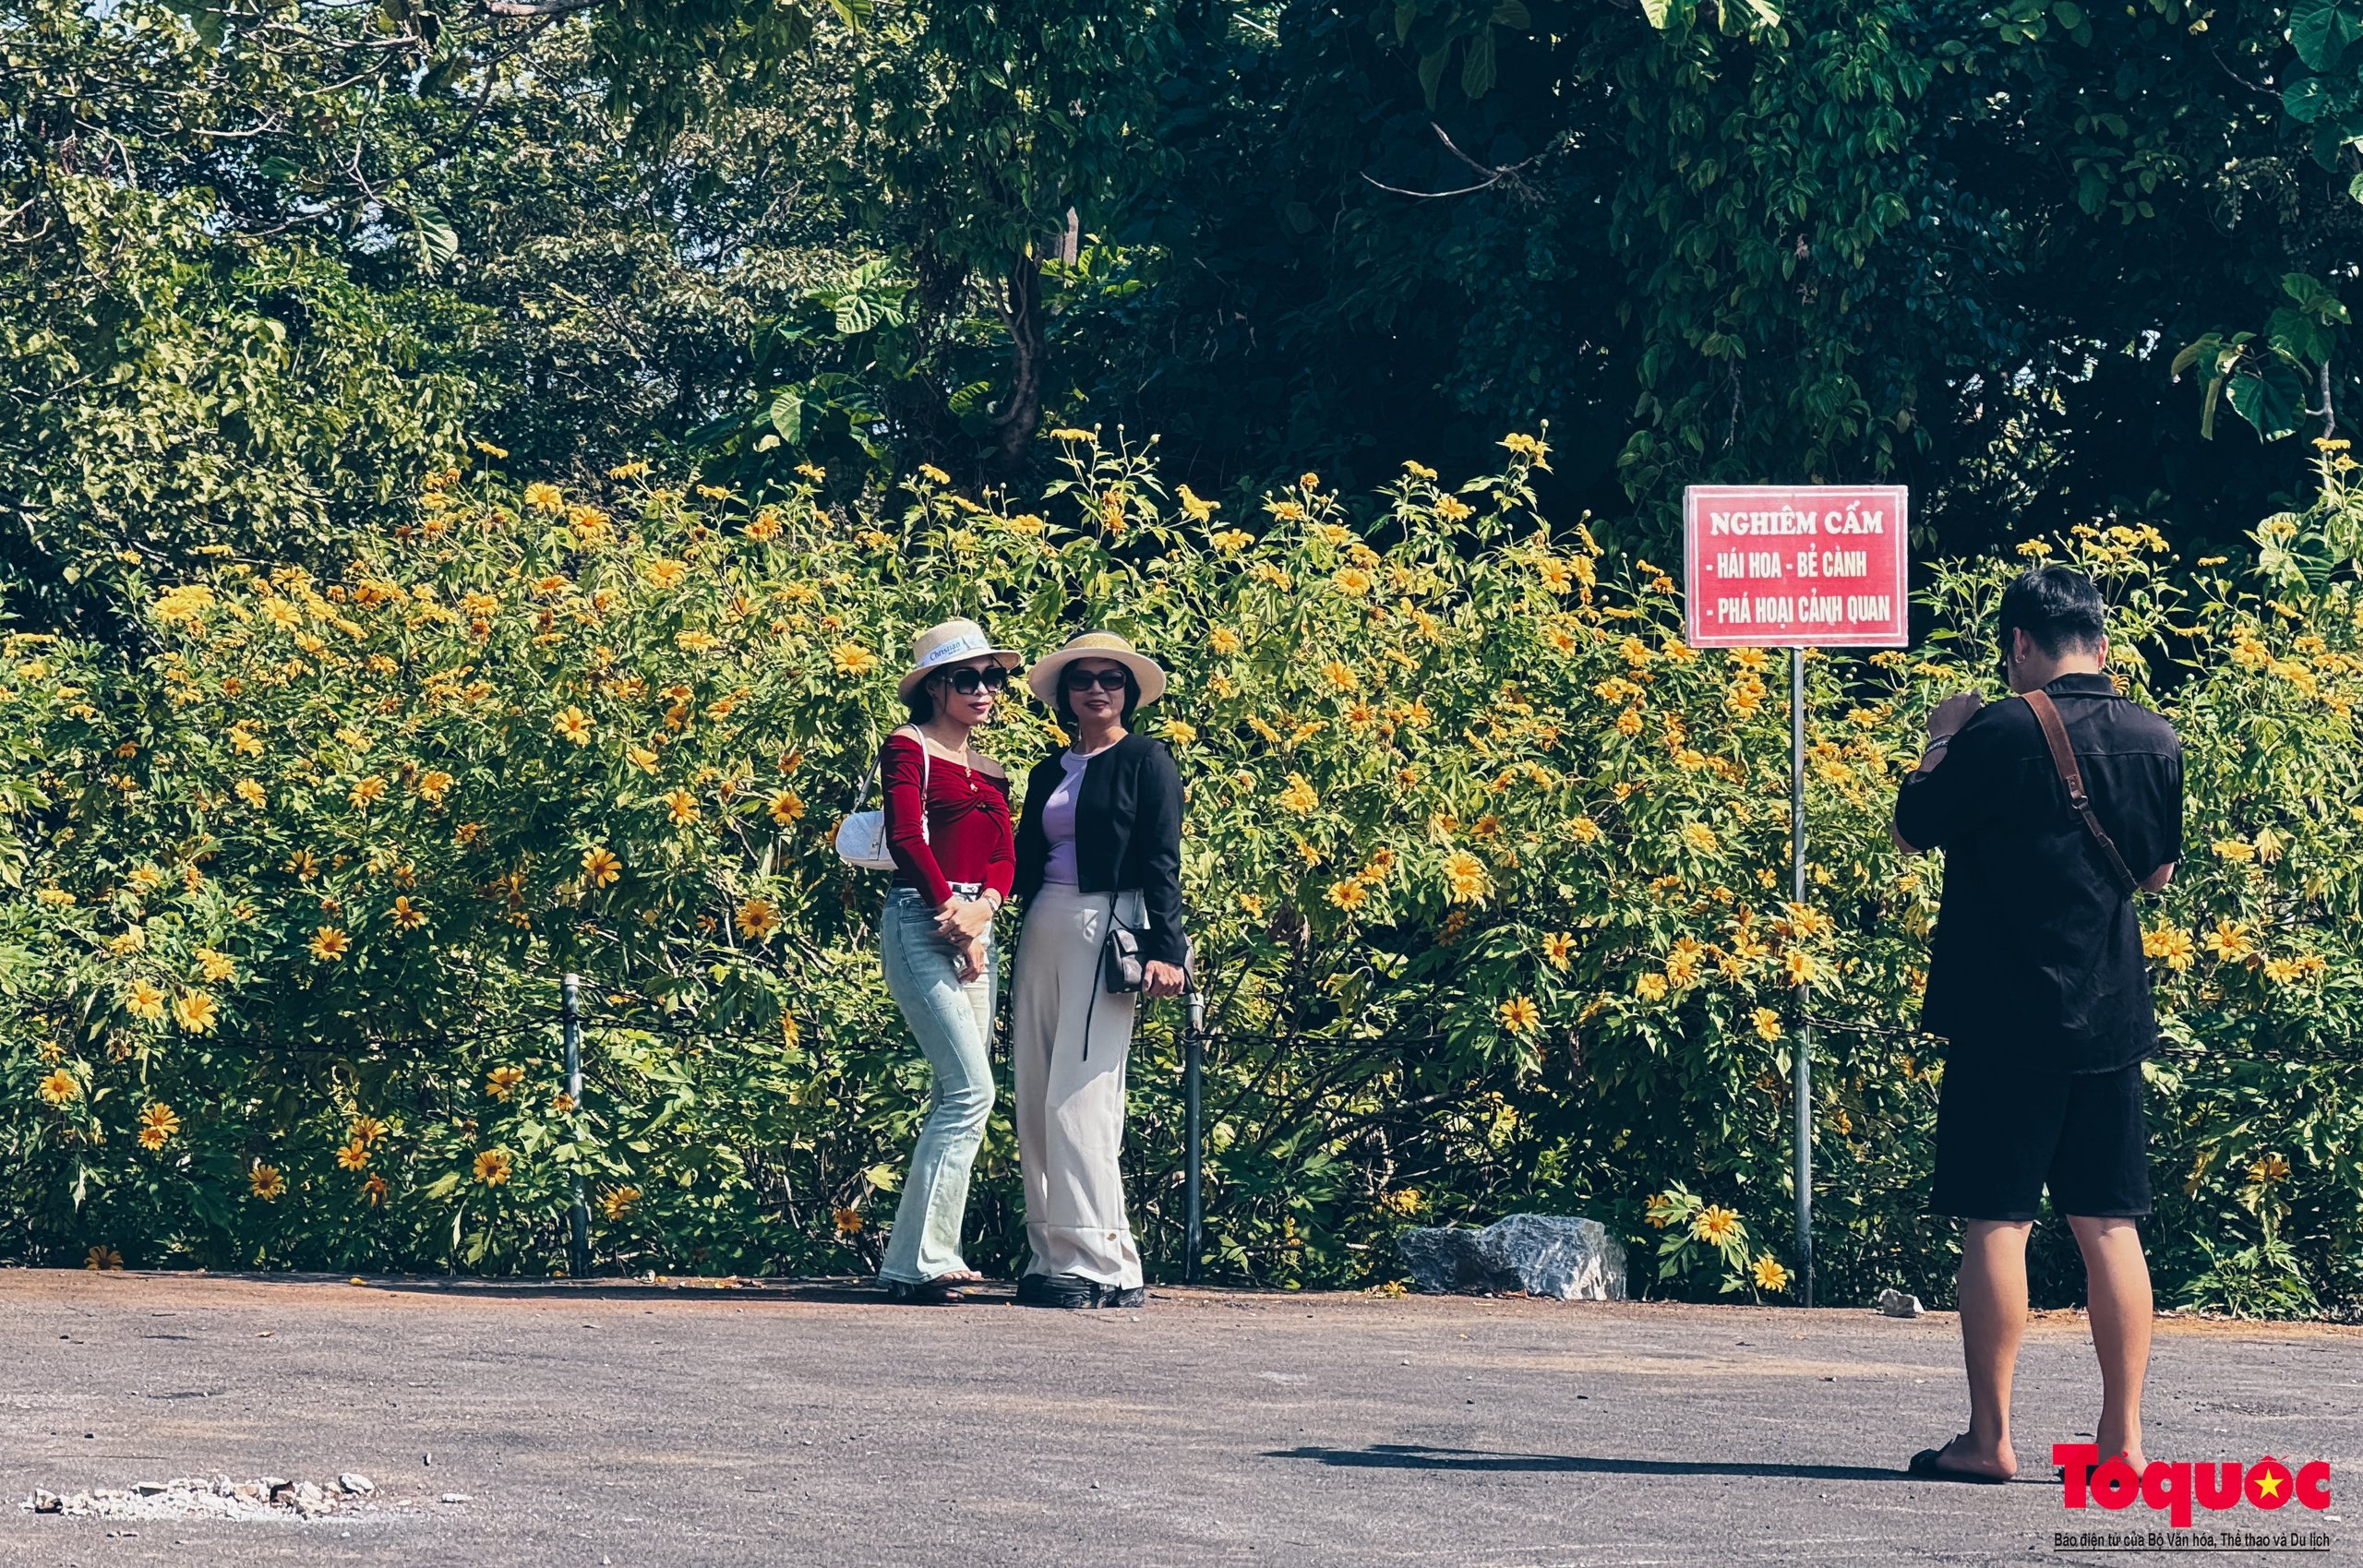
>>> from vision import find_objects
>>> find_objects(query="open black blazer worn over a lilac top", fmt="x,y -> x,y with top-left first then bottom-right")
1016,735 -> 1189,964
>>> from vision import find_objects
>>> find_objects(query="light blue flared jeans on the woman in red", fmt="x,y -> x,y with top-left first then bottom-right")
879,888 -> 997,1285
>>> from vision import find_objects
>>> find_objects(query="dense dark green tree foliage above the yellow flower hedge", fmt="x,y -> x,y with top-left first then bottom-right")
0,0 -> 2363,637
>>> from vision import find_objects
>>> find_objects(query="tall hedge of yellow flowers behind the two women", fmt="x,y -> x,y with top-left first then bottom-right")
0,432 -> 2363,1299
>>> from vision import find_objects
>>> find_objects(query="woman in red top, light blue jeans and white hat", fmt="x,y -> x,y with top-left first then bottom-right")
879,621 -> 1018,1303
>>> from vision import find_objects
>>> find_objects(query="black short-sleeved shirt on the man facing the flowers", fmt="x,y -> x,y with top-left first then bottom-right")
1895,676 -> 2183,1072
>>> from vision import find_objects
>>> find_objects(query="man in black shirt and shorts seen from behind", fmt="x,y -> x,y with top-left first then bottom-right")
1893,567 -> 2183,1480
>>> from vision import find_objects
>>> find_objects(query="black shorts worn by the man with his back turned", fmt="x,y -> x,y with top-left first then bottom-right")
1928,1051 -> 2151,1221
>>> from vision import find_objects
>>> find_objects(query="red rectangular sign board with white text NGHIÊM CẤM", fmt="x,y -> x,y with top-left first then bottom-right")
1683,485 -> 1909,647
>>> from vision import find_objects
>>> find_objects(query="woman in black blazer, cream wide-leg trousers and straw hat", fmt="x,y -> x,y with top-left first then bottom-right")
1009,630 -> 1189,1306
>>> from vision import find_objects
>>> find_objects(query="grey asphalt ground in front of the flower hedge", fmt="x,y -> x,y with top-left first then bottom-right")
0,1271 -> 2363,1568
